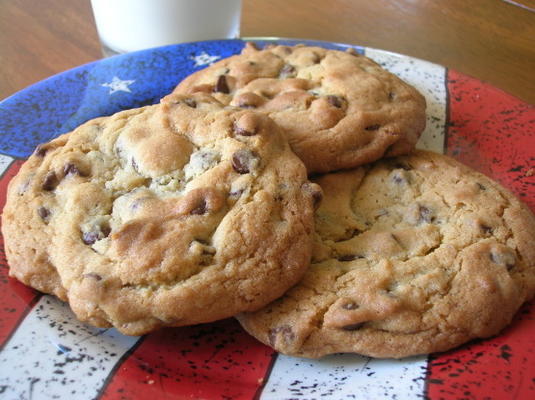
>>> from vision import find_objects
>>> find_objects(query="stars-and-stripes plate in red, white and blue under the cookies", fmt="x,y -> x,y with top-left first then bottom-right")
0,38 -> 535,400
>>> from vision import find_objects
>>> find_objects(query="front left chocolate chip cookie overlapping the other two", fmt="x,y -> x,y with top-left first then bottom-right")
2,93 -> 319,335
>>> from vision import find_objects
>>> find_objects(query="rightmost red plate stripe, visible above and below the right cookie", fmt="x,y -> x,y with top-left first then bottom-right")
427,71 -> 535,399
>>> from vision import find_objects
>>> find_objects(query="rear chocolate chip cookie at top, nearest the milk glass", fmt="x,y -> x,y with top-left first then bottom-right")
175,43 -> 425,173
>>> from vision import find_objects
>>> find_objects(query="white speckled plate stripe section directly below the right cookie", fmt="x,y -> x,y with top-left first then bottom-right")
260,354 -> 427,400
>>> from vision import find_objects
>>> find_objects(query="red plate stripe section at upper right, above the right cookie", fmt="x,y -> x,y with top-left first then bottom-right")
446,70 -> 535,212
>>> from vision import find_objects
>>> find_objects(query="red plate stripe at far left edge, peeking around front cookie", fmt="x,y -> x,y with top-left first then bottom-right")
0,160 -> 39,348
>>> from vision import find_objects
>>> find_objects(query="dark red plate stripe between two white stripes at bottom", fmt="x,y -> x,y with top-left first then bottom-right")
100,319 -> 274,400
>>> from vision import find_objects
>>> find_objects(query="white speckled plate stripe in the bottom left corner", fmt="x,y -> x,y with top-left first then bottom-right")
0,296 -> 139,399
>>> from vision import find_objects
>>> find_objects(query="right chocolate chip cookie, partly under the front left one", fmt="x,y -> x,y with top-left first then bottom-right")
238,151 -> 535,358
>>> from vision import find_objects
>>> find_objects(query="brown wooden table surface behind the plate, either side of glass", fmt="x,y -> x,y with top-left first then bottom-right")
0,0 -> 535,104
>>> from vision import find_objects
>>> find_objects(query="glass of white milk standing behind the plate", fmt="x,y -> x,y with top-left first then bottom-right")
91,0 -> 241,56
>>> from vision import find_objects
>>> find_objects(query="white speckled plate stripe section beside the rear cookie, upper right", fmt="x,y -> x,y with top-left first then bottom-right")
365,48 -> 447,153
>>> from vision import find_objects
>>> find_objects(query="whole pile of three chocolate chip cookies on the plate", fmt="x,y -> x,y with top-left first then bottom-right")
2,45 -> 535,357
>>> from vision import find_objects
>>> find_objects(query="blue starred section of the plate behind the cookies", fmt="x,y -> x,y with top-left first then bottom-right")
0,38 -> 363,158
